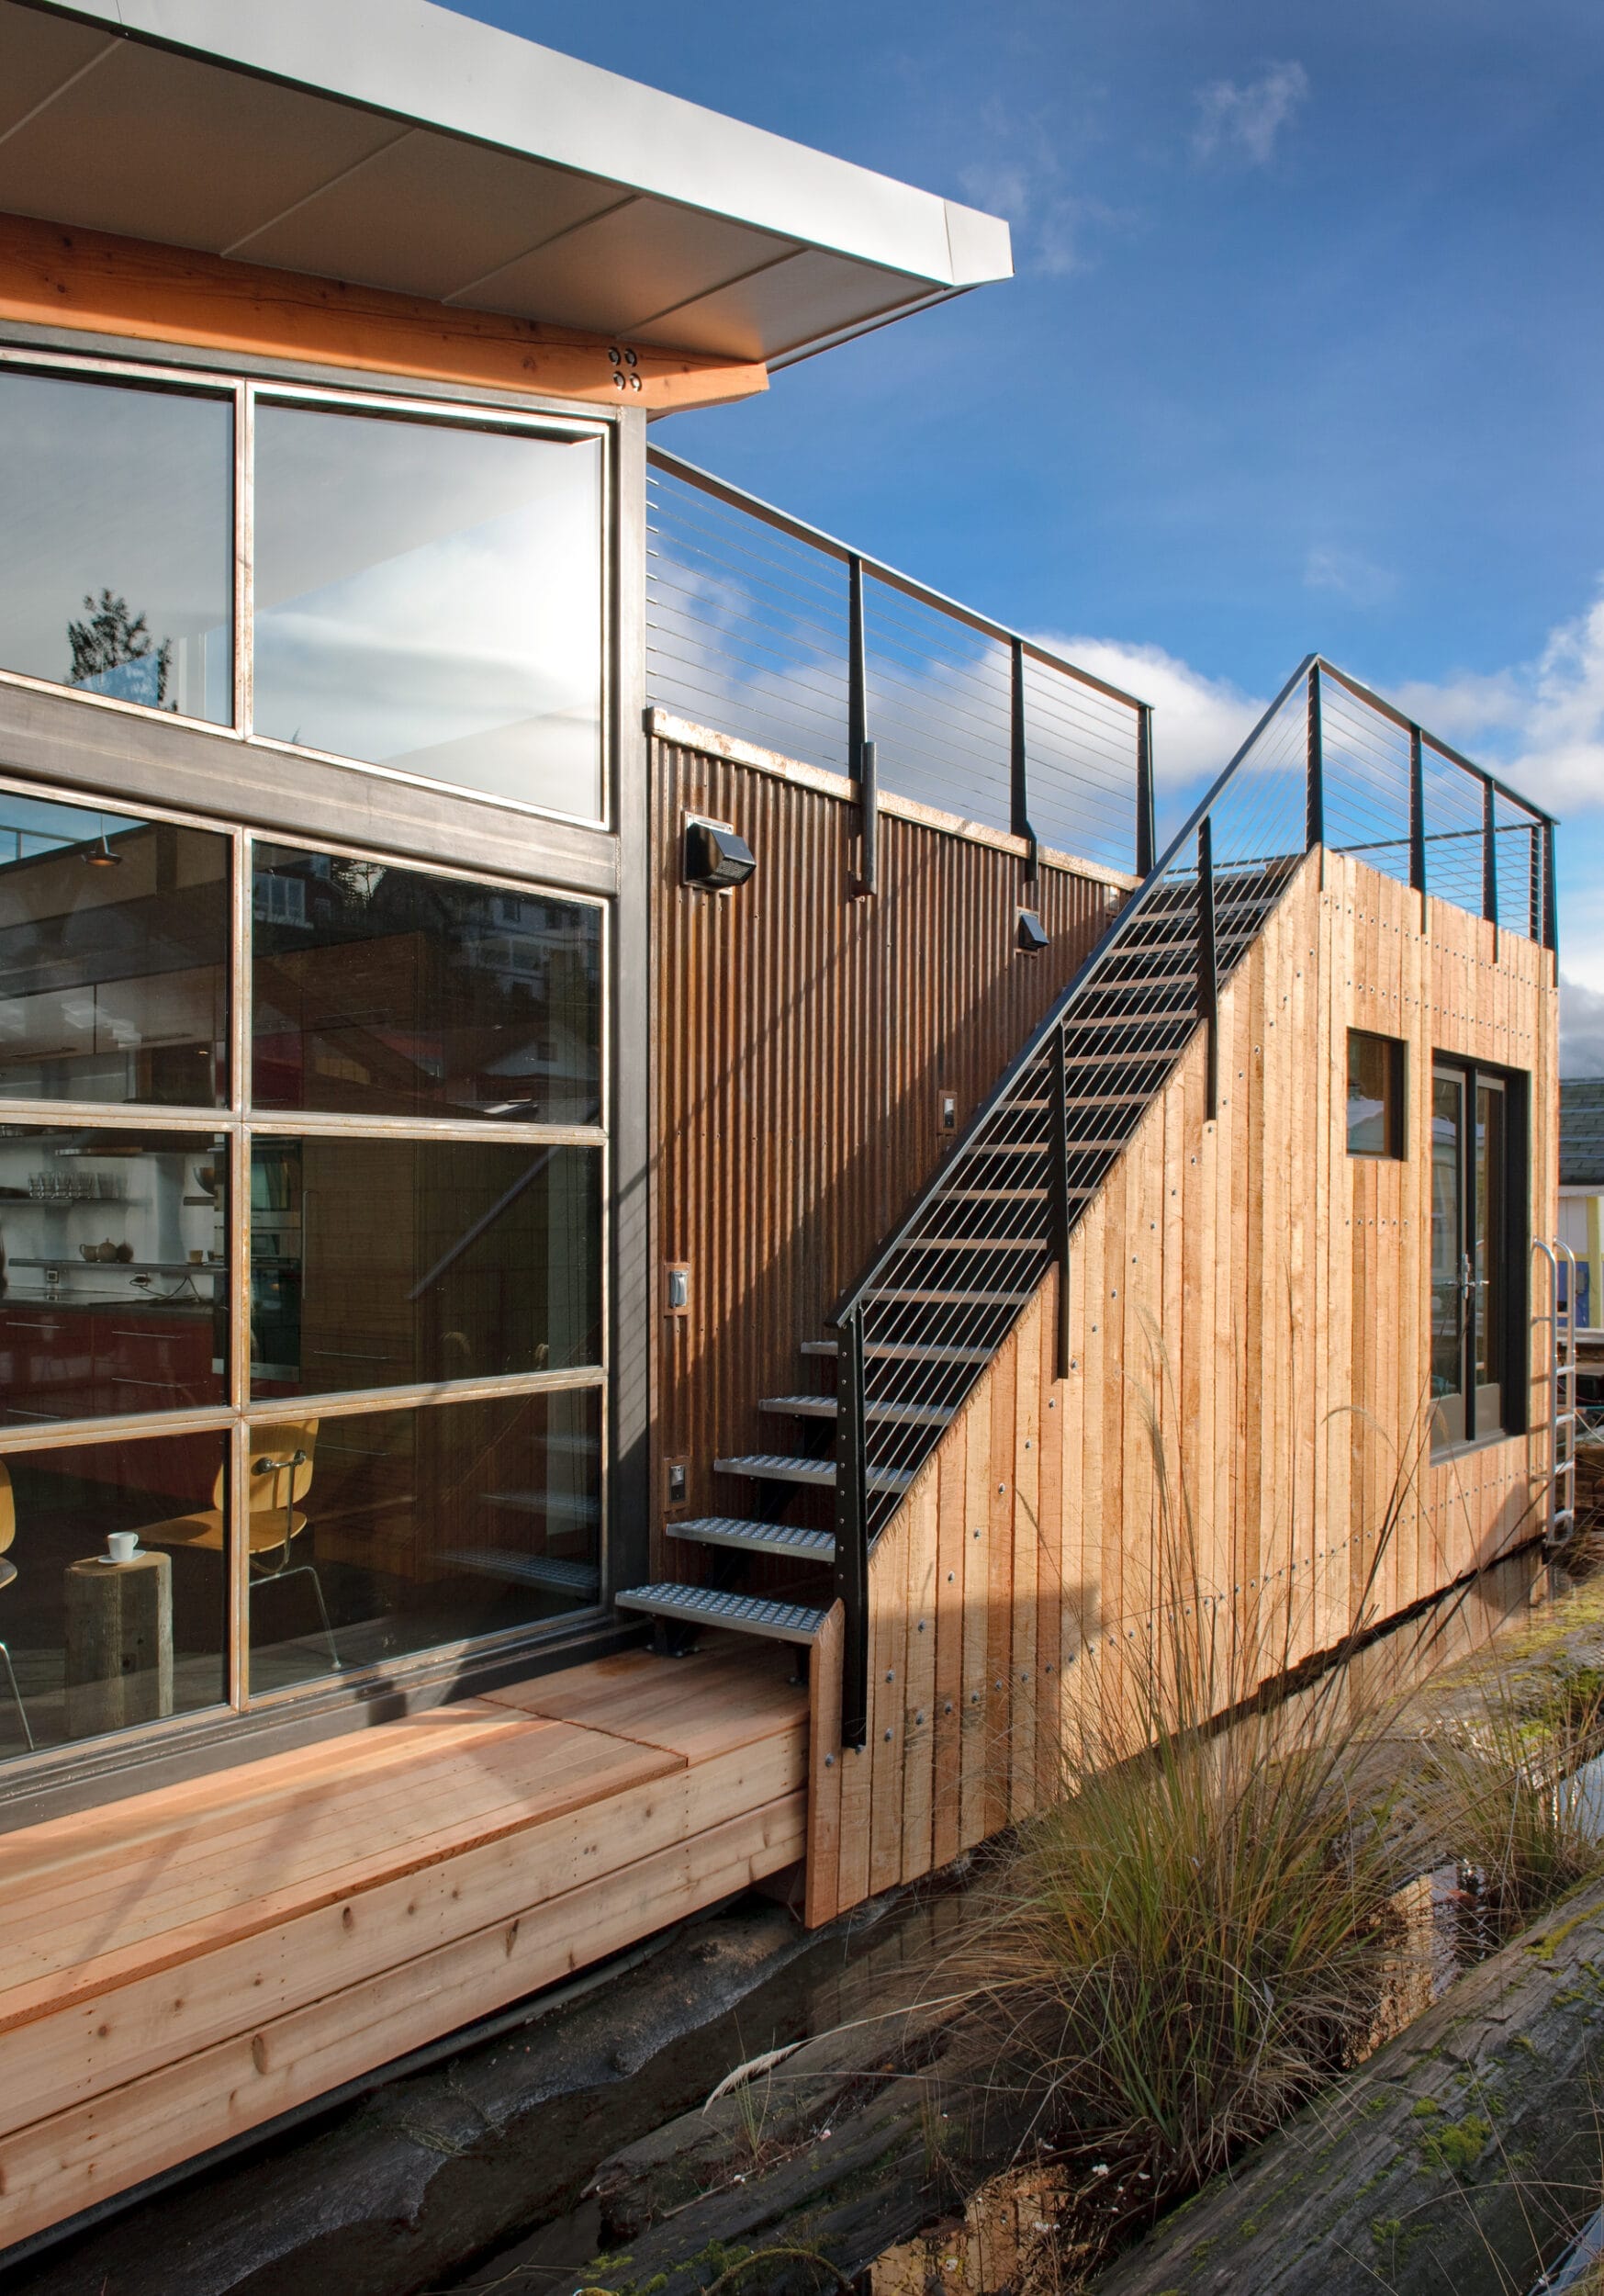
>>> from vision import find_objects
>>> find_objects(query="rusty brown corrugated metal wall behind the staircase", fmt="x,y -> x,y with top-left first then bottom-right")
652,742 -> 1111,1575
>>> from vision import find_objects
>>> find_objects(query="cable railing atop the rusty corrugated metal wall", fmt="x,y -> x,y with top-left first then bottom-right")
647,448 -> 1154,894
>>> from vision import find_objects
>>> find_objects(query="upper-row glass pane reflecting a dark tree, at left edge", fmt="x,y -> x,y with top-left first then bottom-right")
0,372 -> 234,726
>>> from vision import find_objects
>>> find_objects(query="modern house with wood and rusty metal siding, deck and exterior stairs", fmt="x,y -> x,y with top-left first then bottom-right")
0,0 -> 1556,2244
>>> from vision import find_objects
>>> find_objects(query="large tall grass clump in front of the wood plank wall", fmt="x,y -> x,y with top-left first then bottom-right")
970,1368 -> 1430,2216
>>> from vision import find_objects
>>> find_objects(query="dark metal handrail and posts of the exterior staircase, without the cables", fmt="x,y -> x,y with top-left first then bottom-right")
828,652 -> 1558,1750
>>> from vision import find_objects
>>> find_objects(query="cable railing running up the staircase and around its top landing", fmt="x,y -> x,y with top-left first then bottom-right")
833,657 -> 1556,1745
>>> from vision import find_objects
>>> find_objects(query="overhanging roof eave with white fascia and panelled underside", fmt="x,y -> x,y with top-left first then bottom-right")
0,0 -> 1012,366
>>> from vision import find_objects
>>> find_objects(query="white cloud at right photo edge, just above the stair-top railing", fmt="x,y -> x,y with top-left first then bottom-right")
1393,586 -> 1604,813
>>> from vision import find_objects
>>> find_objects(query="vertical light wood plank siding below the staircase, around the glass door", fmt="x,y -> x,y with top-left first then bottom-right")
808,854 -> 1558,1922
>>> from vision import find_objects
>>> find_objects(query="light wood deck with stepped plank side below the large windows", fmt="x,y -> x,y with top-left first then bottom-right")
0,1639 -> 808,2245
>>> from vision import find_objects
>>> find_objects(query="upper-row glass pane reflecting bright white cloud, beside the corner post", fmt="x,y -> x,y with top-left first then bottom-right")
254,402 -> 601,820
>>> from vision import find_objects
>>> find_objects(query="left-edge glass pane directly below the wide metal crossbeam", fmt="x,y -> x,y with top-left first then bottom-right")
0,790 -> 230,1109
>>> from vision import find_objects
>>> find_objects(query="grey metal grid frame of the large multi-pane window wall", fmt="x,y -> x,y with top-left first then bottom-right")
0,324 -> 652,1800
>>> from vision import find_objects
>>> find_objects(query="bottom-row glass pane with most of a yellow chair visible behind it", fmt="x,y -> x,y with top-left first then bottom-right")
250,1387 -> 601,1694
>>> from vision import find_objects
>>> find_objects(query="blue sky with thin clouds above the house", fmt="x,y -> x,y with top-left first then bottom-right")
452,0 -> 1604,1073
